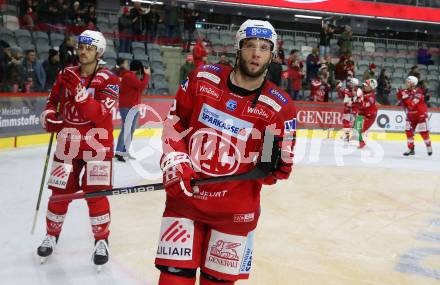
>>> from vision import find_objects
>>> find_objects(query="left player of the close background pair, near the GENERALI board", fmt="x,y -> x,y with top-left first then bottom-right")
336,78 -> 362,142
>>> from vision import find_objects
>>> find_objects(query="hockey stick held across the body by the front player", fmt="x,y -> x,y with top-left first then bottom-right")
49,167 -> 270,202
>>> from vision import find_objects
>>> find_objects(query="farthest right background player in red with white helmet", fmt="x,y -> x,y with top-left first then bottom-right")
396,76 -> 432,156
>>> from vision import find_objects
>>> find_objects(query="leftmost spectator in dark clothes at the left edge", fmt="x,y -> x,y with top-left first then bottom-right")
3,46 -> 23,93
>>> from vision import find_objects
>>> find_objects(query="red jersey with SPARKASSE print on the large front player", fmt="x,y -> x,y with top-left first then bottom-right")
162,65 -> 296,229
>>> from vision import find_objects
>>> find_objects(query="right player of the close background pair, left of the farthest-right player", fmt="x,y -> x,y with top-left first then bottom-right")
358,79 -> 377,148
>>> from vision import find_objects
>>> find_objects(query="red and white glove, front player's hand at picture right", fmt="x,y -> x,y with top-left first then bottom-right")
262,138 -> 295,185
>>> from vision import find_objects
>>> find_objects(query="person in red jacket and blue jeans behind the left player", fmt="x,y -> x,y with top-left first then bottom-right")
115,60 -> 151,162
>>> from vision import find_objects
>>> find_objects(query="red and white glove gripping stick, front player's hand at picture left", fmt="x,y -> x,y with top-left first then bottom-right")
160,152 -> 198,198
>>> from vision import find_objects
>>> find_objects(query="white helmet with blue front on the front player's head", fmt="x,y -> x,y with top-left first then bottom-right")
235,20 -> 278,56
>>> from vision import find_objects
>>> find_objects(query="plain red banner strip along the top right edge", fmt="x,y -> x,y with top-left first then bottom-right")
220,0 -> 440,23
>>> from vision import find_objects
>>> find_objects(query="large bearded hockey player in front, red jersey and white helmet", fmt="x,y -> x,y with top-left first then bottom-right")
155,20 -> 296,285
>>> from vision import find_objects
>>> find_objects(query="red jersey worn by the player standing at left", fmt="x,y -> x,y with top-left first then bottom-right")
45,66 -> 120,158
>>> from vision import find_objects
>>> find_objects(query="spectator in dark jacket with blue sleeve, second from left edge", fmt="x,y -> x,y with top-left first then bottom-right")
21,50 -> 46,92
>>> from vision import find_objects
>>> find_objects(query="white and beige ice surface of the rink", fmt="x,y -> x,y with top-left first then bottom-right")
0,138 -> 440,285
